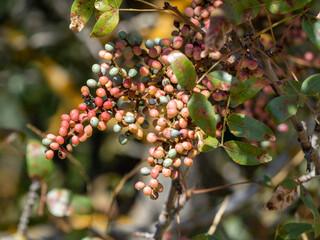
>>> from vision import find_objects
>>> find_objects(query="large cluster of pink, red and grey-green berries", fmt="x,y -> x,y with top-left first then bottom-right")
42,0 -> 278,199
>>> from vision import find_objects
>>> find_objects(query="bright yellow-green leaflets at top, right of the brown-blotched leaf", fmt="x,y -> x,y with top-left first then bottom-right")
90,0 -> 122,37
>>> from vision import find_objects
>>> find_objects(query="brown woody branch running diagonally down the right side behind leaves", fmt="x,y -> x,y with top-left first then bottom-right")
245,21 -> 320,175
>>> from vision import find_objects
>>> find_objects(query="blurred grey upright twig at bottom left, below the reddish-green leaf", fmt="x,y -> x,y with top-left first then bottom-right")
17,179 -> 41,236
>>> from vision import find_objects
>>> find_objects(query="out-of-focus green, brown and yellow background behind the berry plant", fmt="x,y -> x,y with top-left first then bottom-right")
0,0 -> 320,240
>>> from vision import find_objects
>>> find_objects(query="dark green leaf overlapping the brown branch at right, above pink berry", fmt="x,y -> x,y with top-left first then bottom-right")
266,95 -> 298,123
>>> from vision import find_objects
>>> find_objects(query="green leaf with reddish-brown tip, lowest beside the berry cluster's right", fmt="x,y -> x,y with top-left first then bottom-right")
223,141 -> 272,165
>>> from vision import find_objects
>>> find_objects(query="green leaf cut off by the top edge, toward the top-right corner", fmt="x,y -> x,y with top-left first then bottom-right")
264,0 -> 312,14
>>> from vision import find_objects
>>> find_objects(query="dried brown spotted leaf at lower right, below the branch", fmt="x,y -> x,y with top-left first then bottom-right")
264,178 -> 298,211
